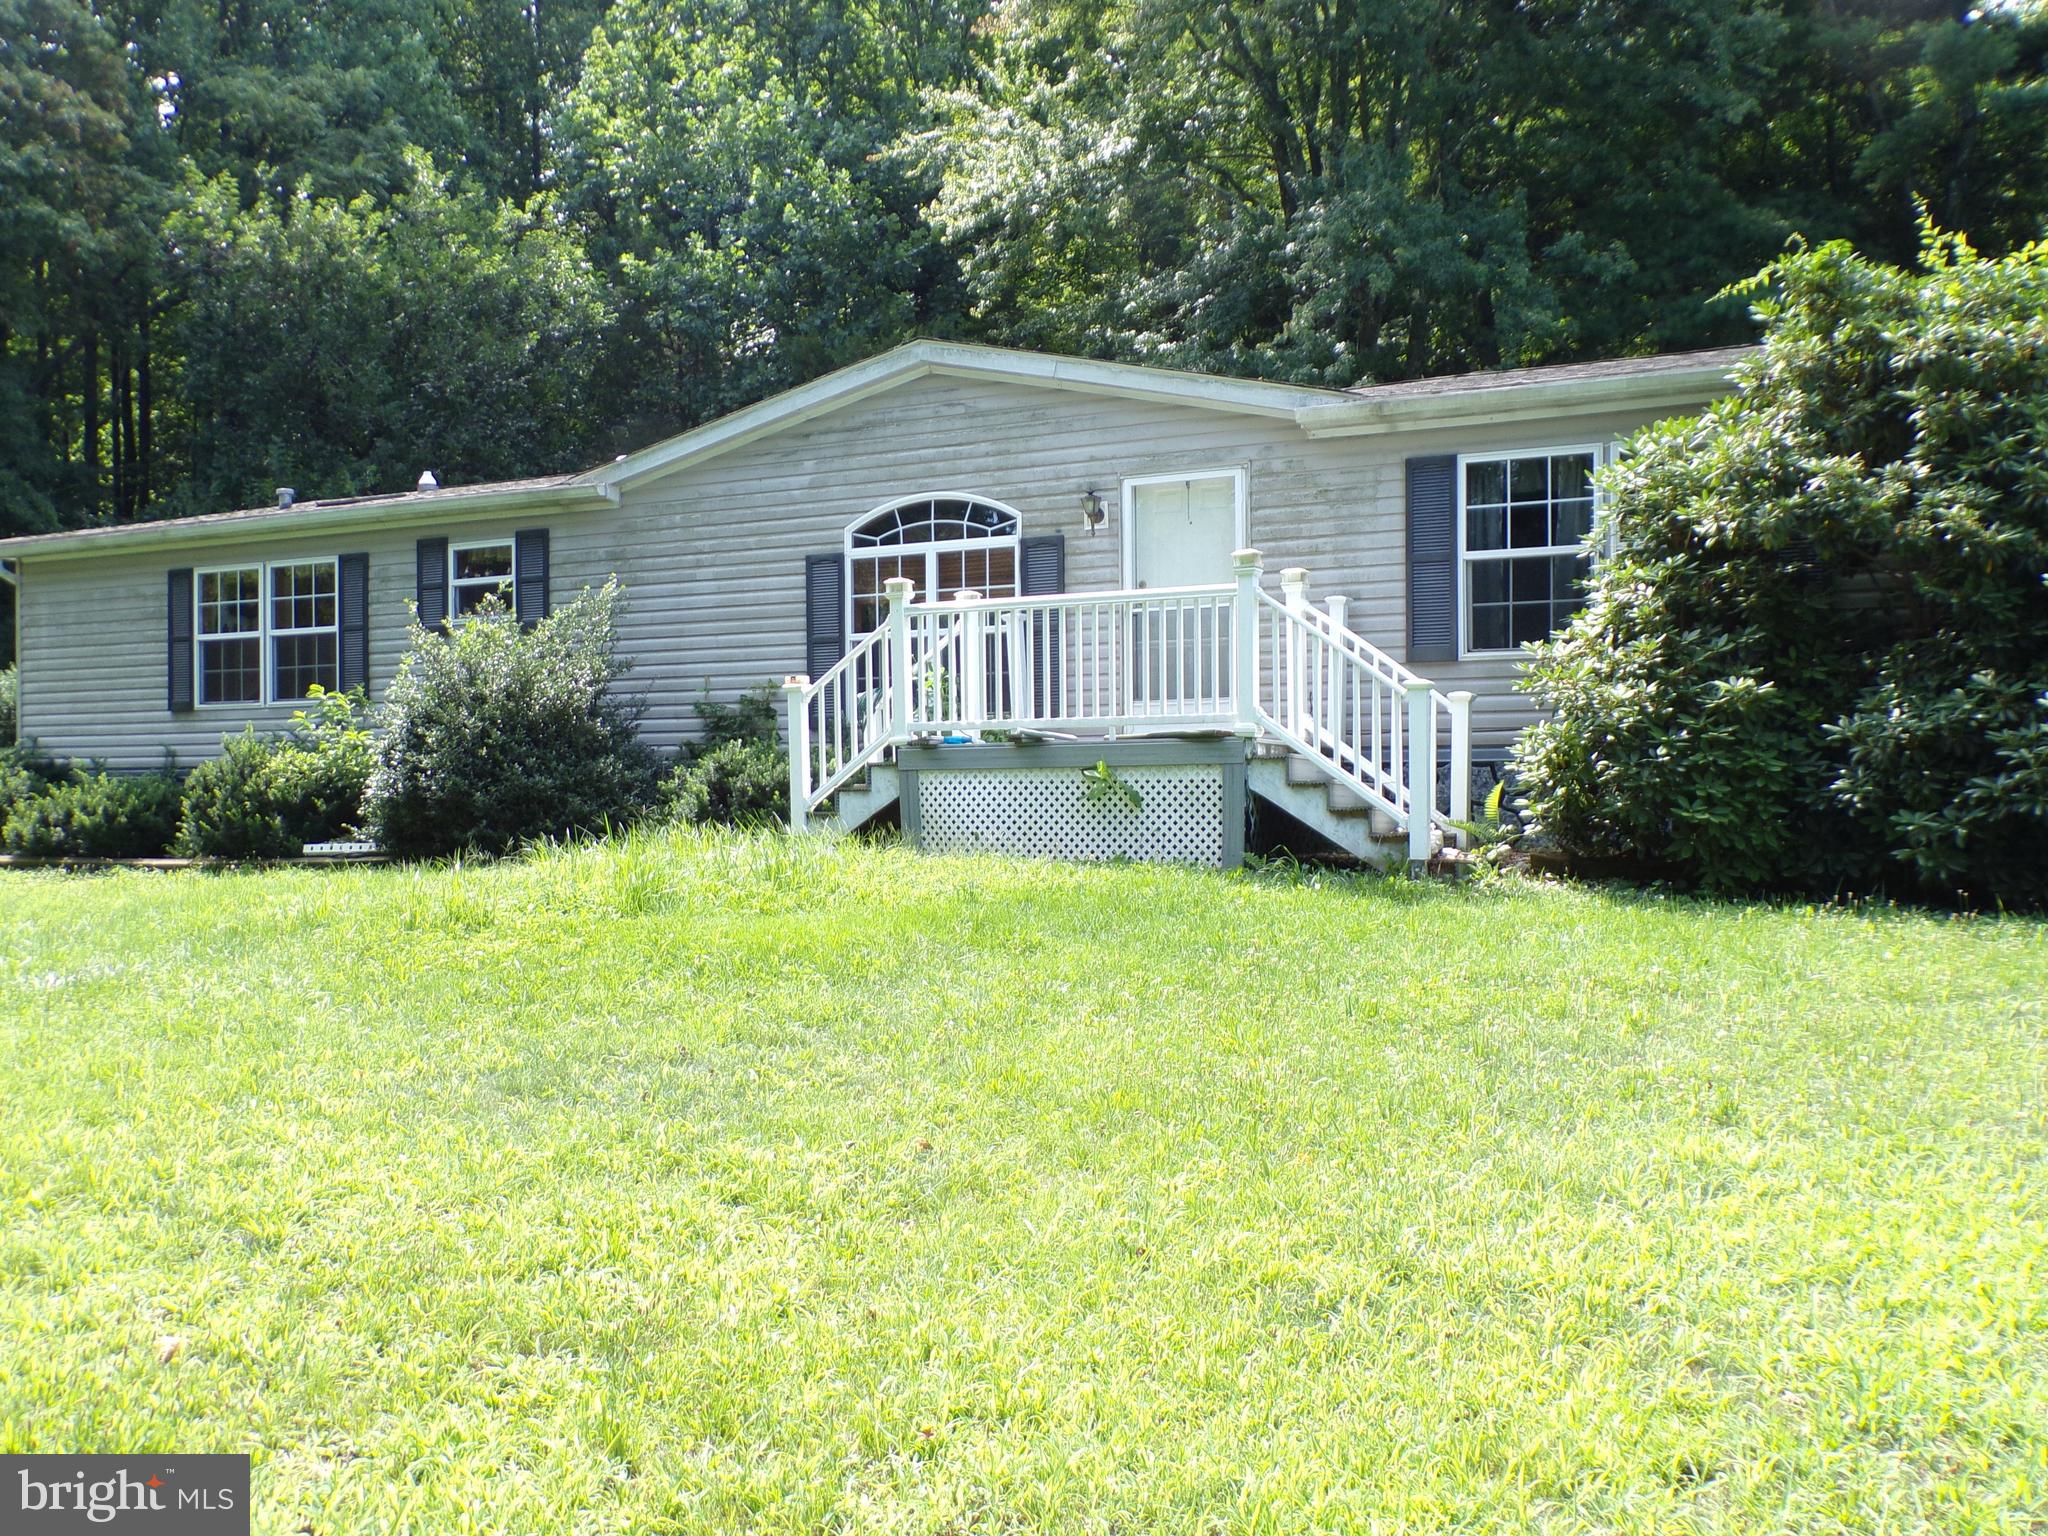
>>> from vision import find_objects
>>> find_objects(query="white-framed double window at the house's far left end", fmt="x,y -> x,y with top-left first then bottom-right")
193,559 -> 340,705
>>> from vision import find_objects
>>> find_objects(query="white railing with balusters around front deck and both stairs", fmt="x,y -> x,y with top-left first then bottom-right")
784,549 -> 1473,860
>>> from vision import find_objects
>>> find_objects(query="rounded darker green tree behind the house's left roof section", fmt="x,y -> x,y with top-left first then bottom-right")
170,160 -> 610,512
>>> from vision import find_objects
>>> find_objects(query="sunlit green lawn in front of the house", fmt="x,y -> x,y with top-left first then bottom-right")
0,836 -> 2048,1536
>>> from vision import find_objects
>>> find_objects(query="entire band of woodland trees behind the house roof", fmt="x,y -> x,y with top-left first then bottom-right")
0,0 -> 2048,536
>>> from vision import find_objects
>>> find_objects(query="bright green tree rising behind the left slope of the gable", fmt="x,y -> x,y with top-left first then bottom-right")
561,0 -> 965,434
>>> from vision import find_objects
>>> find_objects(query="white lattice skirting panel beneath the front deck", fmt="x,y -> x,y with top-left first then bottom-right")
918,764 -> 1225,864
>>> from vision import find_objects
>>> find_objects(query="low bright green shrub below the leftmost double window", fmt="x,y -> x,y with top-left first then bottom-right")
178,694 -> 375,858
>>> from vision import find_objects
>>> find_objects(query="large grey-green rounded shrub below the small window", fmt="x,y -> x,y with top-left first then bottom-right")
365,582 -> 655,856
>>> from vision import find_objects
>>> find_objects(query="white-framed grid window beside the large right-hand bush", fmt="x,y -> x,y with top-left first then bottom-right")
1458,449 -> 1602,655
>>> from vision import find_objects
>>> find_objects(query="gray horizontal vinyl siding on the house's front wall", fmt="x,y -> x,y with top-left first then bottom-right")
20,377 -> 1712,768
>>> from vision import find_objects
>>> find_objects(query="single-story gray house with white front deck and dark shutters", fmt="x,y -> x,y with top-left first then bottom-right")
0,340 -> 1747,862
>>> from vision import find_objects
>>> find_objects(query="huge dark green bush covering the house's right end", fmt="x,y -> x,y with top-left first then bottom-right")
1522,224 -> 2048,903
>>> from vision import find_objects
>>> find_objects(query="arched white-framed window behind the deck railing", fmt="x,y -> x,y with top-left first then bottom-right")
846,492 -> 1018,641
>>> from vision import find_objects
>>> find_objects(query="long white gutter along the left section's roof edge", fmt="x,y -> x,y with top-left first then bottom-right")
0,485 -> 618,561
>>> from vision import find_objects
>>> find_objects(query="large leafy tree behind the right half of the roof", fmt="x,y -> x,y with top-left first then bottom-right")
913,0 -> 2042,385
